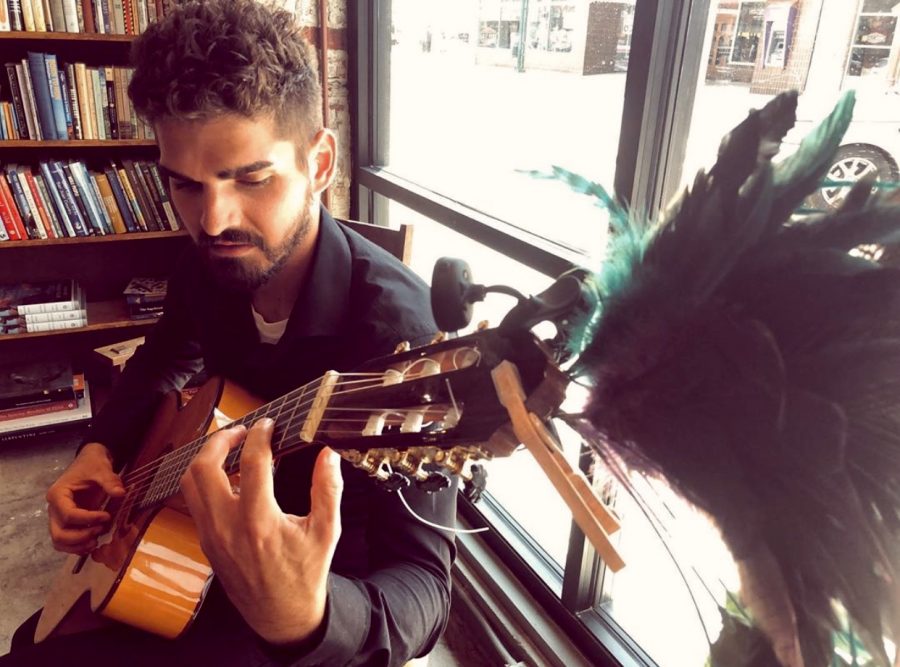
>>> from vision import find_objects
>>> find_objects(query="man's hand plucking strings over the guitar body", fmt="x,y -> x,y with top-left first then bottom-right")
47,442 -> 125,554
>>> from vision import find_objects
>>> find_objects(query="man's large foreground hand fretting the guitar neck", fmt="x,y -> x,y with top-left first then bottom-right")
181,419 -> 343,644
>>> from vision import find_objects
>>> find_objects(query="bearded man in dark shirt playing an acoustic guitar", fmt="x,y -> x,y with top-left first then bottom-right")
0,0 -> 455,667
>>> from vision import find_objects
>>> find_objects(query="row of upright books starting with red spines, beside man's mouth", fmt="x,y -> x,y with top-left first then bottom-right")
0,160 -> 181,241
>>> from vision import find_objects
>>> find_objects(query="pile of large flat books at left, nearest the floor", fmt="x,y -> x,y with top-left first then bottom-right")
0,362 -> 91,442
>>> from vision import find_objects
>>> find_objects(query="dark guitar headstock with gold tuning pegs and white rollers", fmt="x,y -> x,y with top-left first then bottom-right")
315,329 -> 567,489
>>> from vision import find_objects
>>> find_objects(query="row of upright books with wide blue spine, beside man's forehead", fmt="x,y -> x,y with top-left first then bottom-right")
0,51 -> 153,141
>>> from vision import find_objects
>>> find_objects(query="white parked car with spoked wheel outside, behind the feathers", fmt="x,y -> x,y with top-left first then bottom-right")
785,90 -> 900,211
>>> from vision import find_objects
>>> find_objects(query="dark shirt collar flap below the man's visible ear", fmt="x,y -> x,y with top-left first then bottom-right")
285,207 -> 351,337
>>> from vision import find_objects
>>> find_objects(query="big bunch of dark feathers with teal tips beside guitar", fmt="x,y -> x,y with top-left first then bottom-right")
557,93 -> 900,667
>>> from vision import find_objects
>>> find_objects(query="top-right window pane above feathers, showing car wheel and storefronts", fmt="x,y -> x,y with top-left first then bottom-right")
680,0 -> 900,210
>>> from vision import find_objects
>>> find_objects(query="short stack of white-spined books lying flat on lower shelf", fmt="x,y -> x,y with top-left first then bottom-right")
0,279 -> 87,335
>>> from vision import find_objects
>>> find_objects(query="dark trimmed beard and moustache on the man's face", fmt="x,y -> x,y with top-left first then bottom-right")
197,191 -> 312,292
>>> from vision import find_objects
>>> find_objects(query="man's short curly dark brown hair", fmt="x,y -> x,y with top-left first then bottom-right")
128,0 -> 323,145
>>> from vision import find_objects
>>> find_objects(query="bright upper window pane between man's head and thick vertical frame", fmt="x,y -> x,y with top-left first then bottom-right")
386,0 -> 634,251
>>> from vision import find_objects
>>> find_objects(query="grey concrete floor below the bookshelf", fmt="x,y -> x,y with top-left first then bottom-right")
0,436 -> 473,667
